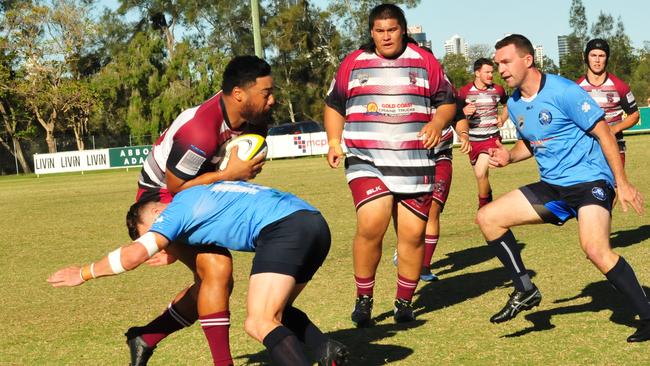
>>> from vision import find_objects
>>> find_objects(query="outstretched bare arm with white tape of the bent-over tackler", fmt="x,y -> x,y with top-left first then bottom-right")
47,232 -> 169,287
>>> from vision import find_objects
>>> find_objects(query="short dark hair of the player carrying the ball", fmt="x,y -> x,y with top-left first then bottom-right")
221,55 -> 271,95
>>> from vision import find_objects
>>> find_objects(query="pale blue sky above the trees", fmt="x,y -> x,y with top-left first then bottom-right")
98,0 -> 650,63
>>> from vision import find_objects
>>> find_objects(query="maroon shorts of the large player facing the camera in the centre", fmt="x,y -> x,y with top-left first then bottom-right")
348,177 -> 432,221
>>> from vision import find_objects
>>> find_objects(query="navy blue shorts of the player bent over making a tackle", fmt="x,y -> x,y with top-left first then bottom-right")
251,210 -> 331,284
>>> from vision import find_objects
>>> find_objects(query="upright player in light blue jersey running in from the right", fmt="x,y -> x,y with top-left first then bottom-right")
477,34 -> 650,342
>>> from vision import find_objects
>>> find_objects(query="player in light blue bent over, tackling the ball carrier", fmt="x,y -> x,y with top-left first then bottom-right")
48,182 -> 348,366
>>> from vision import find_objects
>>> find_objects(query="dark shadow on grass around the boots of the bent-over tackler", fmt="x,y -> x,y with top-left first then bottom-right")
237,320 -> 425,366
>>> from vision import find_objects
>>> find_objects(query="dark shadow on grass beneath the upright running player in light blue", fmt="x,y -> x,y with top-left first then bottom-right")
504,281 -> 650,338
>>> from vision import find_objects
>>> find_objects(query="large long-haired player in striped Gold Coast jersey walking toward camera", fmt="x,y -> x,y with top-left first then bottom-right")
324,4 -> 455,327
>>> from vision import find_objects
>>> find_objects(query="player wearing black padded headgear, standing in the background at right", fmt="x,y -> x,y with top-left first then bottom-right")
576,38 -> 640,166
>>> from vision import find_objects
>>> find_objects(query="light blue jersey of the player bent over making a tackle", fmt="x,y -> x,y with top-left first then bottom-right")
149,181 -> 318,252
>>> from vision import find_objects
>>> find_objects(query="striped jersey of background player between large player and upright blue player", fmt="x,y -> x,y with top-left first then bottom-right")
456,82 -> 508,141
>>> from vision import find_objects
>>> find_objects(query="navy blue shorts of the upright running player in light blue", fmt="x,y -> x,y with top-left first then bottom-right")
519,180 -> 616,225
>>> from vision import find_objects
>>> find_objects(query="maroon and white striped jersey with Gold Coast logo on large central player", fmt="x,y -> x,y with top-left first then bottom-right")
326,43 -> 454,193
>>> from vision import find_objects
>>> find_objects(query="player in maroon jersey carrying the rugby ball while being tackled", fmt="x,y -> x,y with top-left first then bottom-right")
126,56 -> 275,366
